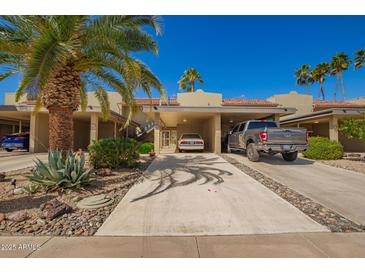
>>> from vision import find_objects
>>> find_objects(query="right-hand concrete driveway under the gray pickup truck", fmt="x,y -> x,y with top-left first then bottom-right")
226,153 -> 365,225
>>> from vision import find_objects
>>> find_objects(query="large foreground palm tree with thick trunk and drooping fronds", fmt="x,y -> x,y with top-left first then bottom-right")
0,16 -> 163,152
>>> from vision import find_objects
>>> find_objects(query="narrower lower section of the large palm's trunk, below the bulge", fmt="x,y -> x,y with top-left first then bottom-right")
48,106 -> 74,152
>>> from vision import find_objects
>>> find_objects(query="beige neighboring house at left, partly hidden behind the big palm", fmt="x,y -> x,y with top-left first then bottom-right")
0,92 -> 139,152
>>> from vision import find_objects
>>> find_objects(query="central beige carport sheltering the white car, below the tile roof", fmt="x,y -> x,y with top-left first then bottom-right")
143,104 -> 295,153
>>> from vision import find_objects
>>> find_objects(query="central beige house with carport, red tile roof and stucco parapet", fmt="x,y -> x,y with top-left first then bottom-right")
122,90 -> 296,153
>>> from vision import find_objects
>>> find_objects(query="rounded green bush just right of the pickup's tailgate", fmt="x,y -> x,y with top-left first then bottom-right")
303,137 -> 343,160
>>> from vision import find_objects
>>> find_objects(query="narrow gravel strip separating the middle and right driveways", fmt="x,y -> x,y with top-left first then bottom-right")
221,155 -> 365,232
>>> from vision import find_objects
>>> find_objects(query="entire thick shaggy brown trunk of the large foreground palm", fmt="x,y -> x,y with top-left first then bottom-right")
42,65 -> 81,152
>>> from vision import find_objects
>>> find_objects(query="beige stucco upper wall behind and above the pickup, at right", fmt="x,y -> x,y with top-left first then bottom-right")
267,91 -> 313,115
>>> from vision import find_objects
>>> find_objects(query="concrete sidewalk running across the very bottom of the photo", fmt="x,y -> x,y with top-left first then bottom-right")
0,233 -> 365,258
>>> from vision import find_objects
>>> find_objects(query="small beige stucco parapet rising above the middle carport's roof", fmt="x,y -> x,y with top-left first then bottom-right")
176,89 -> 222,107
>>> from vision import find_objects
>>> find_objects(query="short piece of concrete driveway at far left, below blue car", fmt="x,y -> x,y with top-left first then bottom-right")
0,152 -> 47,172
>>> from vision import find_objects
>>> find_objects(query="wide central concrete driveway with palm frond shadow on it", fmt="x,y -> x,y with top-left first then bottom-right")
96,153 -> 328,236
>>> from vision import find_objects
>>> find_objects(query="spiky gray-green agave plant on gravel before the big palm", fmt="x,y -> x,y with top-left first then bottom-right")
28,150 -> 95,191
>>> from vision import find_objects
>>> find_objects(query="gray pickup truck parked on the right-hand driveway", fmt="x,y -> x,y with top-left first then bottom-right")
227,120 -> 308,162
